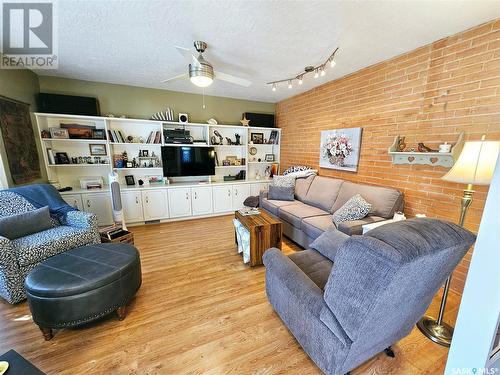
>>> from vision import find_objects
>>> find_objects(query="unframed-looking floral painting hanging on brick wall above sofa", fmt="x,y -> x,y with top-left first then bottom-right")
319,128 -> 362,172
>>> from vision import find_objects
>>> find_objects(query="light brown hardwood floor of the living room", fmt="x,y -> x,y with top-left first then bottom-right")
0,216 -> 460,375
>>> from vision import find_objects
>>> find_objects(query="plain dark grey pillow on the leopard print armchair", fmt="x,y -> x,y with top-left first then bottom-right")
0,206 -> 52,240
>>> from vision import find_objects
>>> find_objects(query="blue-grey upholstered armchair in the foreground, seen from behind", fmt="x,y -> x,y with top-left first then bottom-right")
264,219 -> 475,375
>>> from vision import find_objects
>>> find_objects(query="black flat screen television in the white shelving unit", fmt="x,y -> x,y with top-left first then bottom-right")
161,146 -> 215,177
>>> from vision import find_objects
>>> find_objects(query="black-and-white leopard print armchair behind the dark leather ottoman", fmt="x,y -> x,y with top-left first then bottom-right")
0,191 -> 101,303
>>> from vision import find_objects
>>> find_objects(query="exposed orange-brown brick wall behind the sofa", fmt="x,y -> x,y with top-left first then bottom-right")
276,19 -> 500,292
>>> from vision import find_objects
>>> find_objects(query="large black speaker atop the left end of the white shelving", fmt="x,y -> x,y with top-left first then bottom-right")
38,93 -> 101,116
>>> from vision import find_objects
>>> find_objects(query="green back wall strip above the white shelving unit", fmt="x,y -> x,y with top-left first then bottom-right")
39,76 -> 275,124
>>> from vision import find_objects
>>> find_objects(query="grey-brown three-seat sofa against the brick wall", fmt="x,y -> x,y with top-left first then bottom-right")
259,176 -> 403,248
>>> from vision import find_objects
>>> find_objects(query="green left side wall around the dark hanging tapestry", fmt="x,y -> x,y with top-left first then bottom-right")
0,69 -> 47,186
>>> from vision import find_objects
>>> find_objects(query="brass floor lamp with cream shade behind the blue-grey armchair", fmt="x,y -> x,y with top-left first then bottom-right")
417,135 -> 500,347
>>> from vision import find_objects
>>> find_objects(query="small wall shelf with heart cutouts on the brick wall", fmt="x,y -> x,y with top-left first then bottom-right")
389,133 -> 464,168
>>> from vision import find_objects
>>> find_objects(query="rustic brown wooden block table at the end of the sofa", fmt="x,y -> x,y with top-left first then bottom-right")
234,211 -> 283,267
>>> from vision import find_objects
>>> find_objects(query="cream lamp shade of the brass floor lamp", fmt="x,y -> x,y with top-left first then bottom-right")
443,136 -> 500,185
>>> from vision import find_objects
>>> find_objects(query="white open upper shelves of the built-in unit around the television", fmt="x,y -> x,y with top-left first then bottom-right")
35,113 -> 281,188
